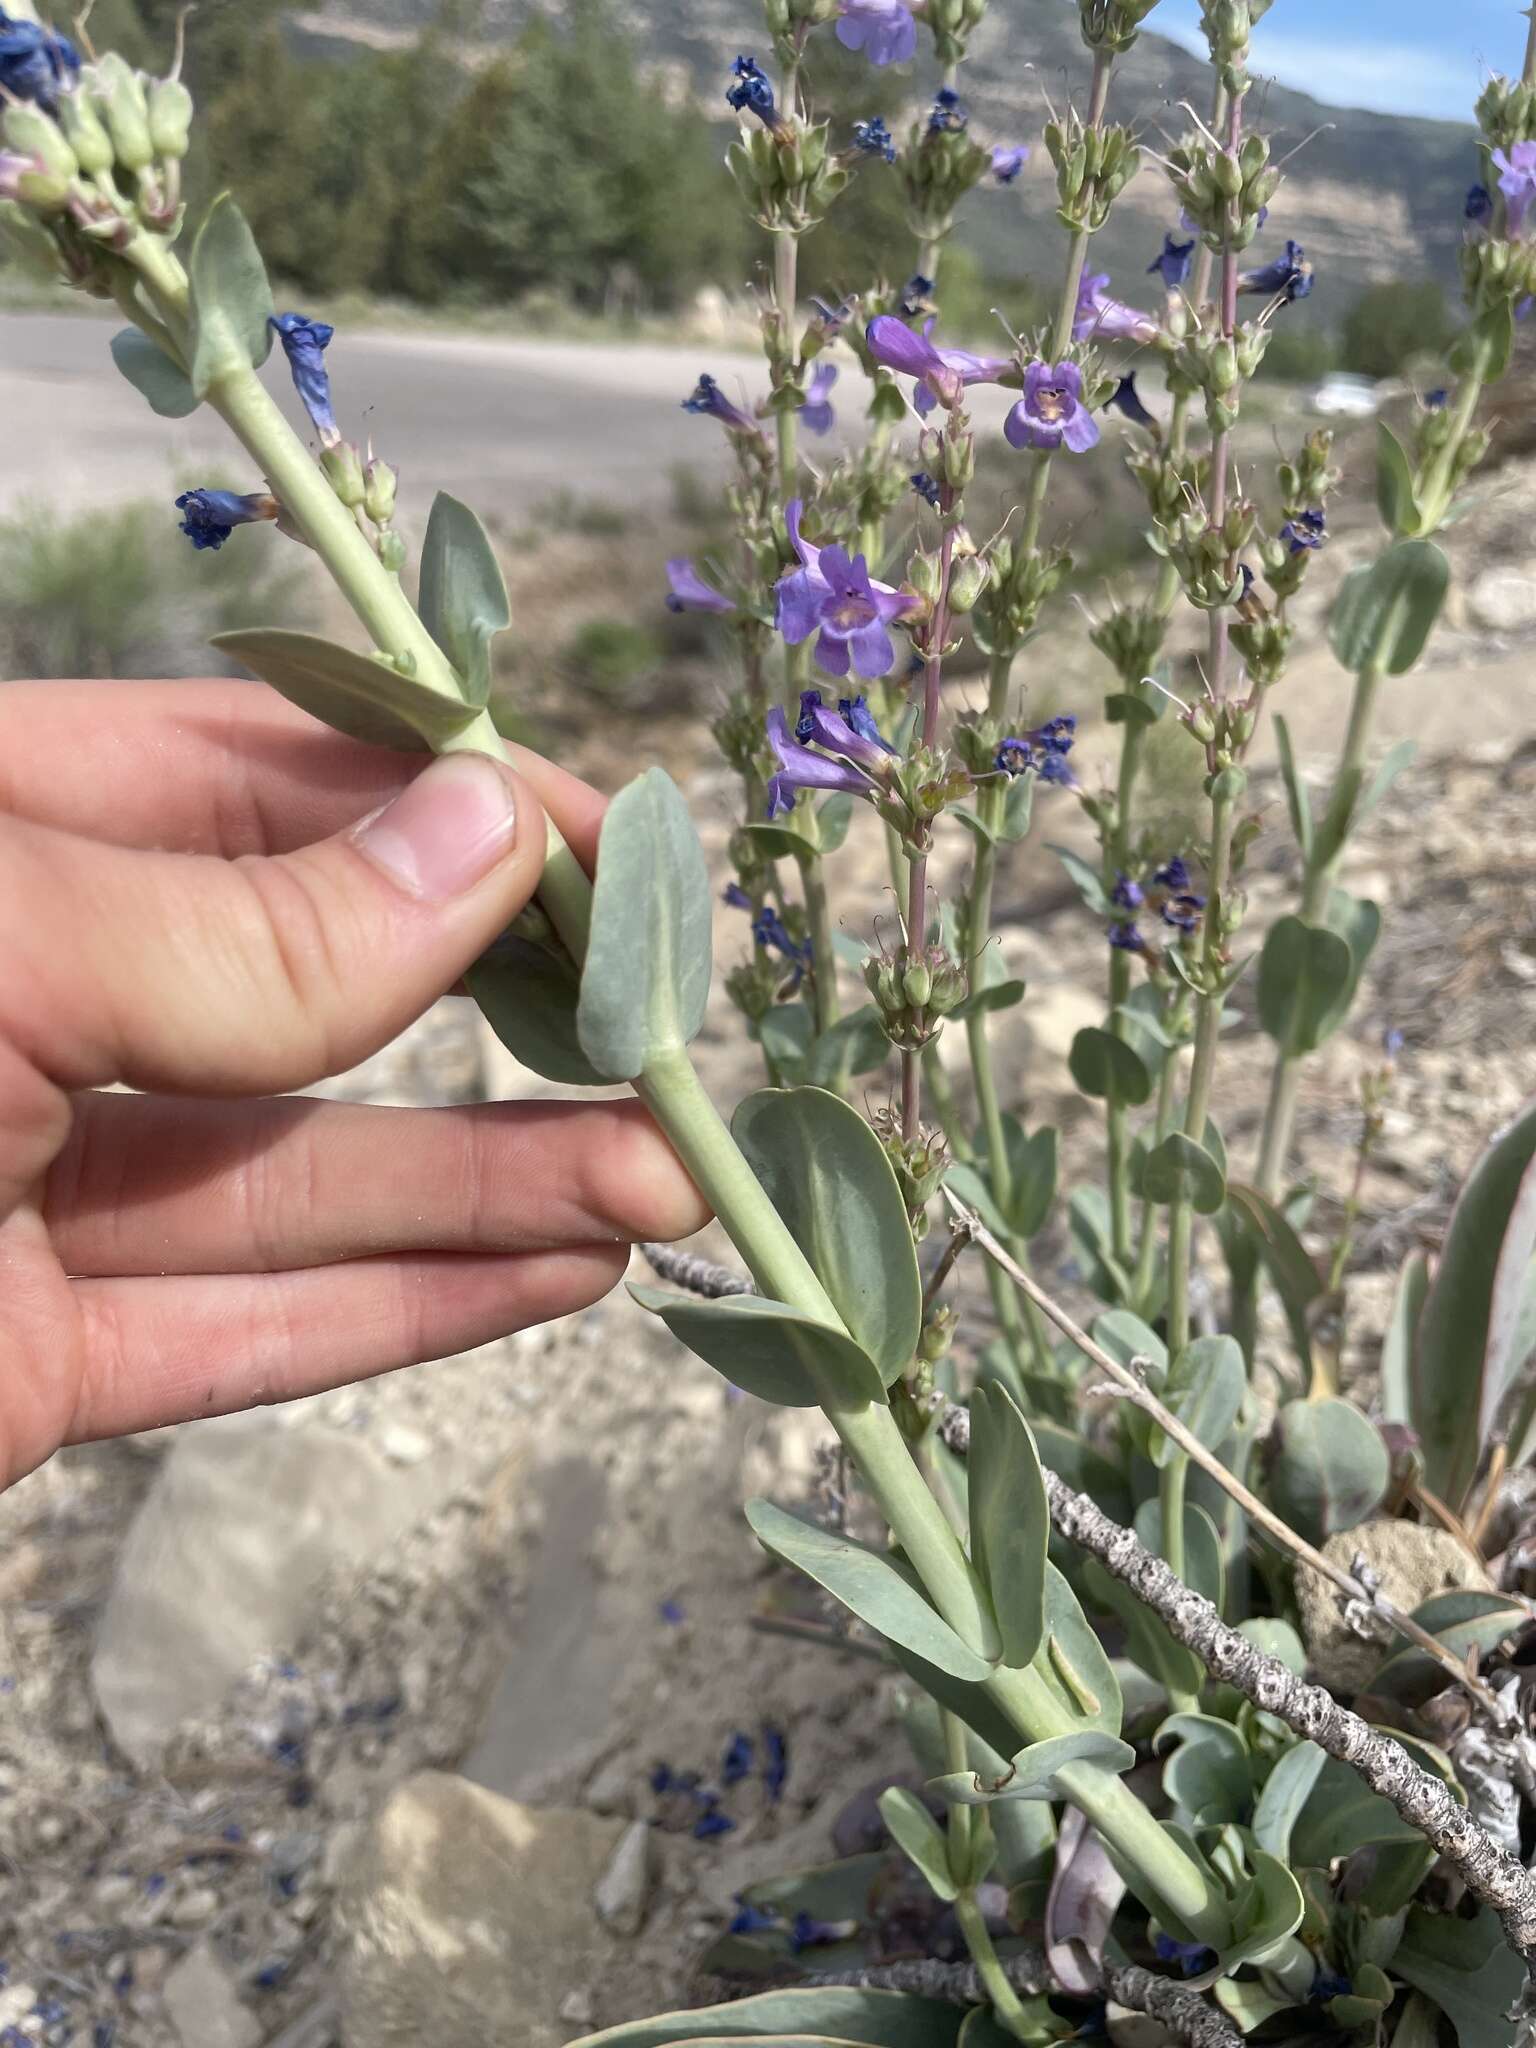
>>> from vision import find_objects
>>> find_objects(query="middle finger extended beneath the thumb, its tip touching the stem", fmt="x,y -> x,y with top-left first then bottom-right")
45,1094 -> 709,1278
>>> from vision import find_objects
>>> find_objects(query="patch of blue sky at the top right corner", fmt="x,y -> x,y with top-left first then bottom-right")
1147,0 -> 1526,121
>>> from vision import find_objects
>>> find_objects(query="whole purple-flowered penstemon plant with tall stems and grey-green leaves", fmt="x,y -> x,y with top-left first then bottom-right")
0,0 -> 1536,2048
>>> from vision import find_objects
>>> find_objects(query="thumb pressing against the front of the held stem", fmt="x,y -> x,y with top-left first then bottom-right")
0,754 -> 545,1217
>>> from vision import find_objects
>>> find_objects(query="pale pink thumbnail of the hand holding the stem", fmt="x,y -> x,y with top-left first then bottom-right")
352,754 -> 518,903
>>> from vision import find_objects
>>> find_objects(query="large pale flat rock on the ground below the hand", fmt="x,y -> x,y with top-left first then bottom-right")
90,1413 -> 438,1769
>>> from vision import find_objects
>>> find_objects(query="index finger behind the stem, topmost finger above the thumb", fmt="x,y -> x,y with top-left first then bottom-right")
0,678 -> 606,872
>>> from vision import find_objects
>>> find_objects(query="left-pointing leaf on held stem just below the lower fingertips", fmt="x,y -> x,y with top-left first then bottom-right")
629,1286 -> 885,1407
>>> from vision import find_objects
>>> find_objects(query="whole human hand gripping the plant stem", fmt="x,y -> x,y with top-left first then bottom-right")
0,682 -> 707,1485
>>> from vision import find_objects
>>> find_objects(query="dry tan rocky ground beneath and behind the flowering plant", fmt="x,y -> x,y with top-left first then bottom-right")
0,440 -> 1536,2048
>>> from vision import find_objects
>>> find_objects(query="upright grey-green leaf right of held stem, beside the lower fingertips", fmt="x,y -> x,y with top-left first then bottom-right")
731,1087 -> 922,1386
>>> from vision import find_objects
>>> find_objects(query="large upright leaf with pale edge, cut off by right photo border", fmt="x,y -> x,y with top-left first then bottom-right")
1409,1102 -> 1536,1507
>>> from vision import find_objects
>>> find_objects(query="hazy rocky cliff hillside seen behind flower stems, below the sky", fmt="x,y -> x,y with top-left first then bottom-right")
297,0 -> 1477,296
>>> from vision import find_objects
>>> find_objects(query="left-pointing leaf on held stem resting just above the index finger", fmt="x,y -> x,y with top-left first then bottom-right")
213,627 -> 475,754
